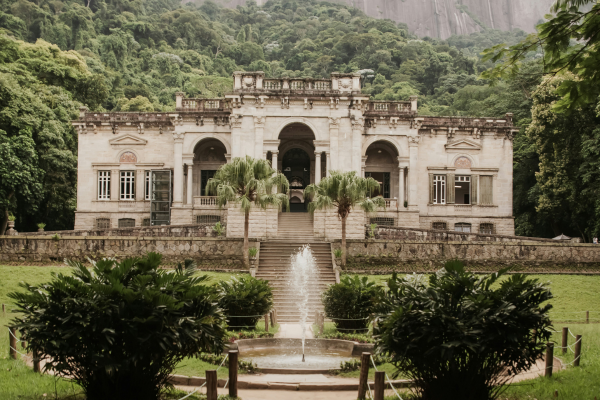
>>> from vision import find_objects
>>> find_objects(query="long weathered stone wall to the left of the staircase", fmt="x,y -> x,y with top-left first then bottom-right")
0,236 -> 250,269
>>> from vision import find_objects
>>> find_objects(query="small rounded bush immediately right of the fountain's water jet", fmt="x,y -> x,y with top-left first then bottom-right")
322,275 -> 383,333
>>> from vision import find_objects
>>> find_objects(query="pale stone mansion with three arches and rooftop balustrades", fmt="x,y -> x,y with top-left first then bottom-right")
73,72 -> 516,239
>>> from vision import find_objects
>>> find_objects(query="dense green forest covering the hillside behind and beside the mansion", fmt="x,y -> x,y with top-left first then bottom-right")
0,0 -> 600,241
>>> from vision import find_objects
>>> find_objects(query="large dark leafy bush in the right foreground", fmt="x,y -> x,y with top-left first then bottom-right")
375,261 -> 552,400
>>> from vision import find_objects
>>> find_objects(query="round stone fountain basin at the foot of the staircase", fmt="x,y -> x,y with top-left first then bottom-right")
236,338 -> 372,374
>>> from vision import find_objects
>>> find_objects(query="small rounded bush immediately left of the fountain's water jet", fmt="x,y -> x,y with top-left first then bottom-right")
217,275 -> 273,331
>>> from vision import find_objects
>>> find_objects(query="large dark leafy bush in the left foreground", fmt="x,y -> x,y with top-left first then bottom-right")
9,253 -> 225,400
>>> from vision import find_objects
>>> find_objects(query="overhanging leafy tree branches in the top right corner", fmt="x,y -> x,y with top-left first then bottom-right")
483,0 -> 600,111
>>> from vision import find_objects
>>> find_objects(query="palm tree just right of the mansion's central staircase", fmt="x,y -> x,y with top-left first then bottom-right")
304,171 -> 385,267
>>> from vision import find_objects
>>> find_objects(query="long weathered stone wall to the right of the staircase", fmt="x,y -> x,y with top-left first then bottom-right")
333,237 -> 600,273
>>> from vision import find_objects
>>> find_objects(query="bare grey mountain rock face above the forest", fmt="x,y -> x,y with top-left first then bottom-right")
209,0 -> 555,39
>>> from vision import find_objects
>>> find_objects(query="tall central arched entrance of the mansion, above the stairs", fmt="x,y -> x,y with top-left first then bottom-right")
279,123 -> 315,212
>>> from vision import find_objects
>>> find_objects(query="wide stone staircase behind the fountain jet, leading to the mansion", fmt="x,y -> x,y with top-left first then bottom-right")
256,213 -> 335,323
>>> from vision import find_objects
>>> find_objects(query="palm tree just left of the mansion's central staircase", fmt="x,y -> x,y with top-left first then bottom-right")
206,156 -> 289,268
